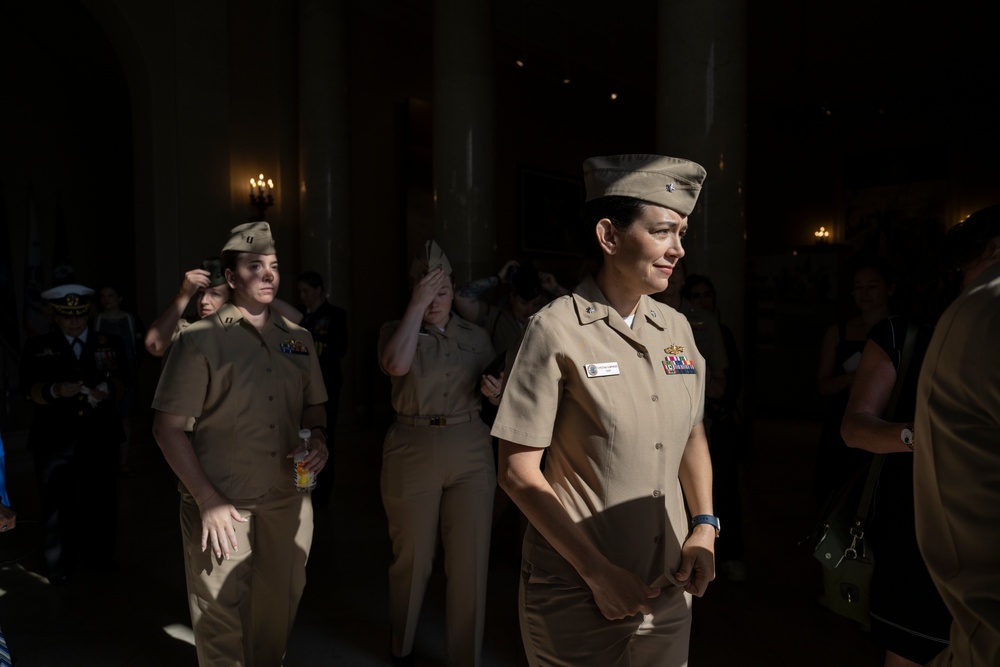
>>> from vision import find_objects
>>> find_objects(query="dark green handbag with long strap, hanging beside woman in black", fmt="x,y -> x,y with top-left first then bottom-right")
813,324 -> 917,628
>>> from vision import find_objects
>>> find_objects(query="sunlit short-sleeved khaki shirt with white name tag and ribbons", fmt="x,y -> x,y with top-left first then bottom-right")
492,278 -> 706,583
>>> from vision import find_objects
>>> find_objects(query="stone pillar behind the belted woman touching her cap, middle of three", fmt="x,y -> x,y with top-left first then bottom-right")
432,0 -> 497,284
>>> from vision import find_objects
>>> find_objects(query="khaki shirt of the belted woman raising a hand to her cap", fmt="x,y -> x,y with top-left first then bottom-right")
378,314 -> 493,417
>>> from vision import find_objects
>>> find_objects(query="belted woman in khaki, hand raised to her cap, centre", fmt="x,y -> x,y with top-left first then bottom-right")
378,241 -> 496,667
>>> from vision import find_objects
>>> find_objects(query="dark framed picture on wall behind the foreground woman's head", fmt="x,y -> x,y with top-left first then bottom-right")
521,168 -> 584,255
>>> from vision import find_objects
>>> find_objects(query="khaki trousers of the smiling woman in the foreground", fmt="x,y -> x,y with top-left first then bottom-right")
519,561 -> 691,667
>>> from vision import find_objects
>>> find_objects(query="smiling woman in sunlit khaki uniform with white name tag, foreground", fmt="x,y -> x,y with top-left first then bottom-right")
493,155 -> 718,667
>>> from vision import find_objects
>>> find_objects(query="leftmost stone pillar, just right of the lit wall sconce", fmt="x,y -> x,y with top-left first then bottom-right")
296,0 -> 351,312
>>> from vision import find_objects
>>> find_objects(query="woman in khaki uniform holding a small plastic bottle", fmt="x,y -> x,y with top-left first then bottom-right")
152,222 -> 329,667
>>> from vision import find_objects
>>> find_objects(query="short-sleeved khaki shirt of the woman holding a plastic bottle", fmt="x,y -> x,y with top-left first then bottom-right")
153,303 -> 327,499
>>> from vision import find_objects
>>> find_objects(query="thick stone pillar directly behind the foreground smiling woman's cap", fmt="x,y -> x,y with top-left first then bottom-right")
656,0 -> 747,350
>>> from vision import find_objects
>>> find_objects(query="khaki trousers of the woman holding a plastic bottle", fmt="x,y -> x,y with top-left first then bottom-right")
180,484 -> 313,667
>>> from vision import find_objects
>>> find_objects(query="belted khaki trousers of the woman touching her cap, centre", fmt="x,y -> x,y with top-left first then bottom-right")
381,417 -> 496,667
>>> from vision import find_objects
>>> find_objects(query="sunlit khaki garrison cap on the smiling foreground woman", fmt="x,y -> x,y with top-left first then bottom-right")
583,154 -> 705,216
